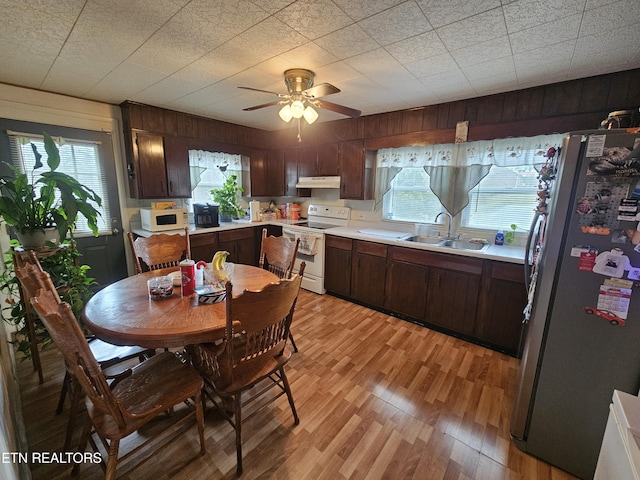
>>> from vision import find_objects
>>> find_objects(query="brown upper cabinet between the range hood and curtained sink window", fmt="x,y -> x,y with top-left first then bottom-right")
339,140 -> 375,200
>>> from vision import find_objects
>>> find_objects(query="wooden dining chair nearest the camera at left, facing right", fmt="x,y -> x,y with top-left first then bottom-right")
31,286 -> 206,480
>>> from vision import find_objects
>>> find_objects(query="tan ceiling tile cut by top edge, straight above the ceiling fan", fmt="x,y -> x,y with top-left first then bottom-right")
275,0 -> 353,40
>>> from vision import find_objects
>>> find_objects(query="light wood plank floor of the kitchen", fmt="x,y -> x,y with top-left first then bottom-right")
19,291 -> 573,480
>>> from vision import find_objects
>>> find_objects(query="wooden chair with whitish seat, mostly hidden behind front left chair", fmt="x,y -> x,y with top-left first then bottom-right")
15,250 -> 155,451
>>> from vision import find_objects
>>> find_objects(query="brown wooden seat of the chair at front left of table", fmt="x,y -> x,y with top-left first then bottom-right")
86,352 -> 204,438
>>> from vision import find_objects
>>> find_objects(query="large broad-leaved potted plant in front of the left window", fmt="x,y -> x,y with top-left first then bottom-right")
0,133 -> 102,248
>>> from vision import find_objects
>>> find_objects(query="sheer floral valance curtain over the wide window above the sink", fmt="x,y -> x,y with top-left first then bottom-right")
375,134 -> 564,216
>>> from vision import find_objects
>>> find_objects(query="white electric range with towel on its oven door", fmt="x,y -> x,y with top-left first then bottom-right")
282,205 -> 351,295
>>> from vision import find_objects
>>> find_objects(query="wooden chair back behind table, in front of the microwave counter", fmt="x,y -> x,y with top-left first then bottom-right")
127,227 -> 191,273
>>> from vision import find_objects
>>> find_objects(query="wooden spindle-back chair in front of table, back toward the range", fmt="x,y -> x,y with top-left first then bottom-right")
187,266 -> 304,476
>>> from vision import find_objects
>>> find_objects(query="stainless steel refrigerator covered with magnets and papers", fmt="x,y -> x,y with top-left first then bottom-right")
510,130 -> 640,479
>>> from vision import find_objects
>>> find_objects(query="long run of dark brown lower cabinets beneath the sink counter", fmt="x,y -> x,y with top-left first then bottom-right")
325,240 -> 527,355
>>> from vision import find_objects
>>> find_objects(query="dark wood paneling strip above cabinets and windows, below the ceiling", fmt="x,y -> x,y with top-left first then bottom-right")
123,69 -> 640,150
